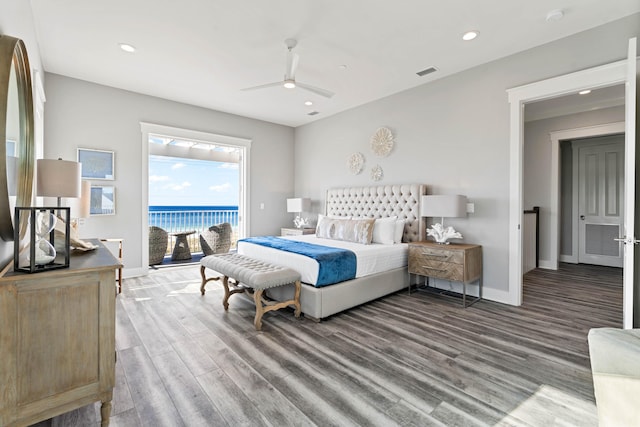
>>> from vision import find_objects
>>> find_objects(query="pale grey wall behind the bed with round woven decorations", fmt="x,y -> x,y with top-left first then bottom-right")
295,15 -> 640,300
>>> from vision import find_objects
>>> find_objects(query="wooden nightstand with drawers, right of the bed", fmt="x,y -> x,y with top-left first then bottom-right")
409,241 -> 482,308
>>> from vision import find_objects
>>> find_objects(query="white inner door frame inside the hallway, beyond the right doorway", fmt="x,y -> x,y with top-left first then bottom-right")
548,122 -> 624,270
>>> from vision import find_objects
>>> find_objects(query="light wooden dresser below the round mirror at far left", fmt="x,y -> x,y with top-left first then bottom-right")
0,240 -> 120,427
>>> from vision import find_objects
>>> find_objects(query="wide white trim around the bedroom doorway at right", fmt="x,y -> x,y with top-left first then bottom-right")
507,60 -> 627,305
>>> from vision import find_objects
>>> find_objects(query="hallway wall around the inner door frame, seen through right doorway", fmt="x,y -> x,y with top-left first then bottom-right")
523,106 -> 624,264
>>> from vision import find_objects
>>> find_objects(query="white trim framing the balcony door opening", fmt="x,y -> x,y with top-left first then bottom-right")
140,122 -> 251,274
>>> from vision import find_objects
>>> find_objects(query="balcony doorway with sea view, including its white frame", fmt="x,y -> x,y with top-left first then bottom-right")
141,123 -> 251,265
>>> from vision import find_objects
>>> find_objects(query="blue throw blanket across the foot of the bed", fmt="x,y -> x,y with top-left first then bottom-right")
240,236 -> 357,288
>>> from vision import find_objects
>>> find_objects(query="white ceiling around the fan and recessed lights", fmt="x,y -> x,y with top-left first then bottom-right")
31,0 -> 640,126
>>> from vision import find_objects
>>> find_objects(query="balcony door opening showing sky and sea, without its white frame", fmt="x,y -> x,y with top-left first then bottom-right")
148,149 -> 240,266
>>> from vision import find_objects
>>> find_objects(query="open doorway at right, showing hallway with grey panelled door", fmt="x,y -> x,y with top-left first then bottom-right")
523,92 -> 625,326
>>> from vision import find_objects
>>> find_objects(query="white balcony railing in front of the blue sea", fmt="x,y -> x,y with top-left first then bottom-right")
149,209 -> 238,255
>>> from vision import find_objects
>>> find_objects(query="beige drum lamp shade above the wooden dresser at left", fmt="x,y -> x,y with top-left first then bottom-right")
36,159 -> 82,197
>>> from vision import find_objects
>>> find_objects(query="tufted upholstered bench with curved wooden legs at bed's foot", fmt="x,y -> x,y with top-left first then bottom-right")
200,253 -> 301,331
